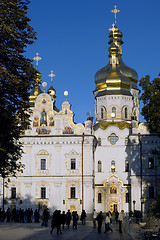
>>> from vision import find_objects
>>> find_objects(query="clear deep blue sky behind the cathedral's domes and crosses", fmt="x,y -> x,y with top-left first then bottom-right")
26,0 -> 160,123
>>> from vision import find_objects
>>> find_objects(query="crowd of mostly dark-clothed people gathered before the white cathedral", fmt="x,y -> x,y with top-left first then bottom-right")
0,208 -> 125,234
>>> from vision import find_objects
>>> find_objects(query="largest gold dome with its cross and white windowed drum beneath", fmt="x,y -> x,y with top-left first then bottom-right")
94,5 -> 139,125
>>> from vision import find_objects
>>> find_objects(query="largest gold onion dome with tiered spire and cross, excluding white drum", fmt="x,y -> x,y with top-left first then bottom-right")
94,5 -> 138,96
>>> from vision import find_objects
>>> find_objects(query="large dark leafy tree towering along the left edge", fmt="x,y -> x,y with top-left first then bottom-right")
0,0 -> 37,177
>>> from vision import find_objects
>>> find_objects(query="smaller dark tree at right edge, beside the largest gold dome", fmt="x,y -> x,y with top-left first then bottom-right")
139,75 -> 160,135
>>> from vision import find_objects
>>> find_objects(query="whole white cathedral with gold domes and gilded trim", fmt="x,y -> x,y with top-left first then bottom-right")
0,6 -> 160,214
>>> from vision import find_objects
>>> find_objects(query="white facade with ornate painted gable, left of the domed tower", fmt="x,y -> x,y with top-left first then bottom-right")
0,93 -> 94,213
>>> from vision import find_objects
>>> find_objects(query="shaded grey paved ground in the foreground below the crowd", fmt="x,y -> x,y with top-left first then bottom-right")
0,222 -> 137,240
